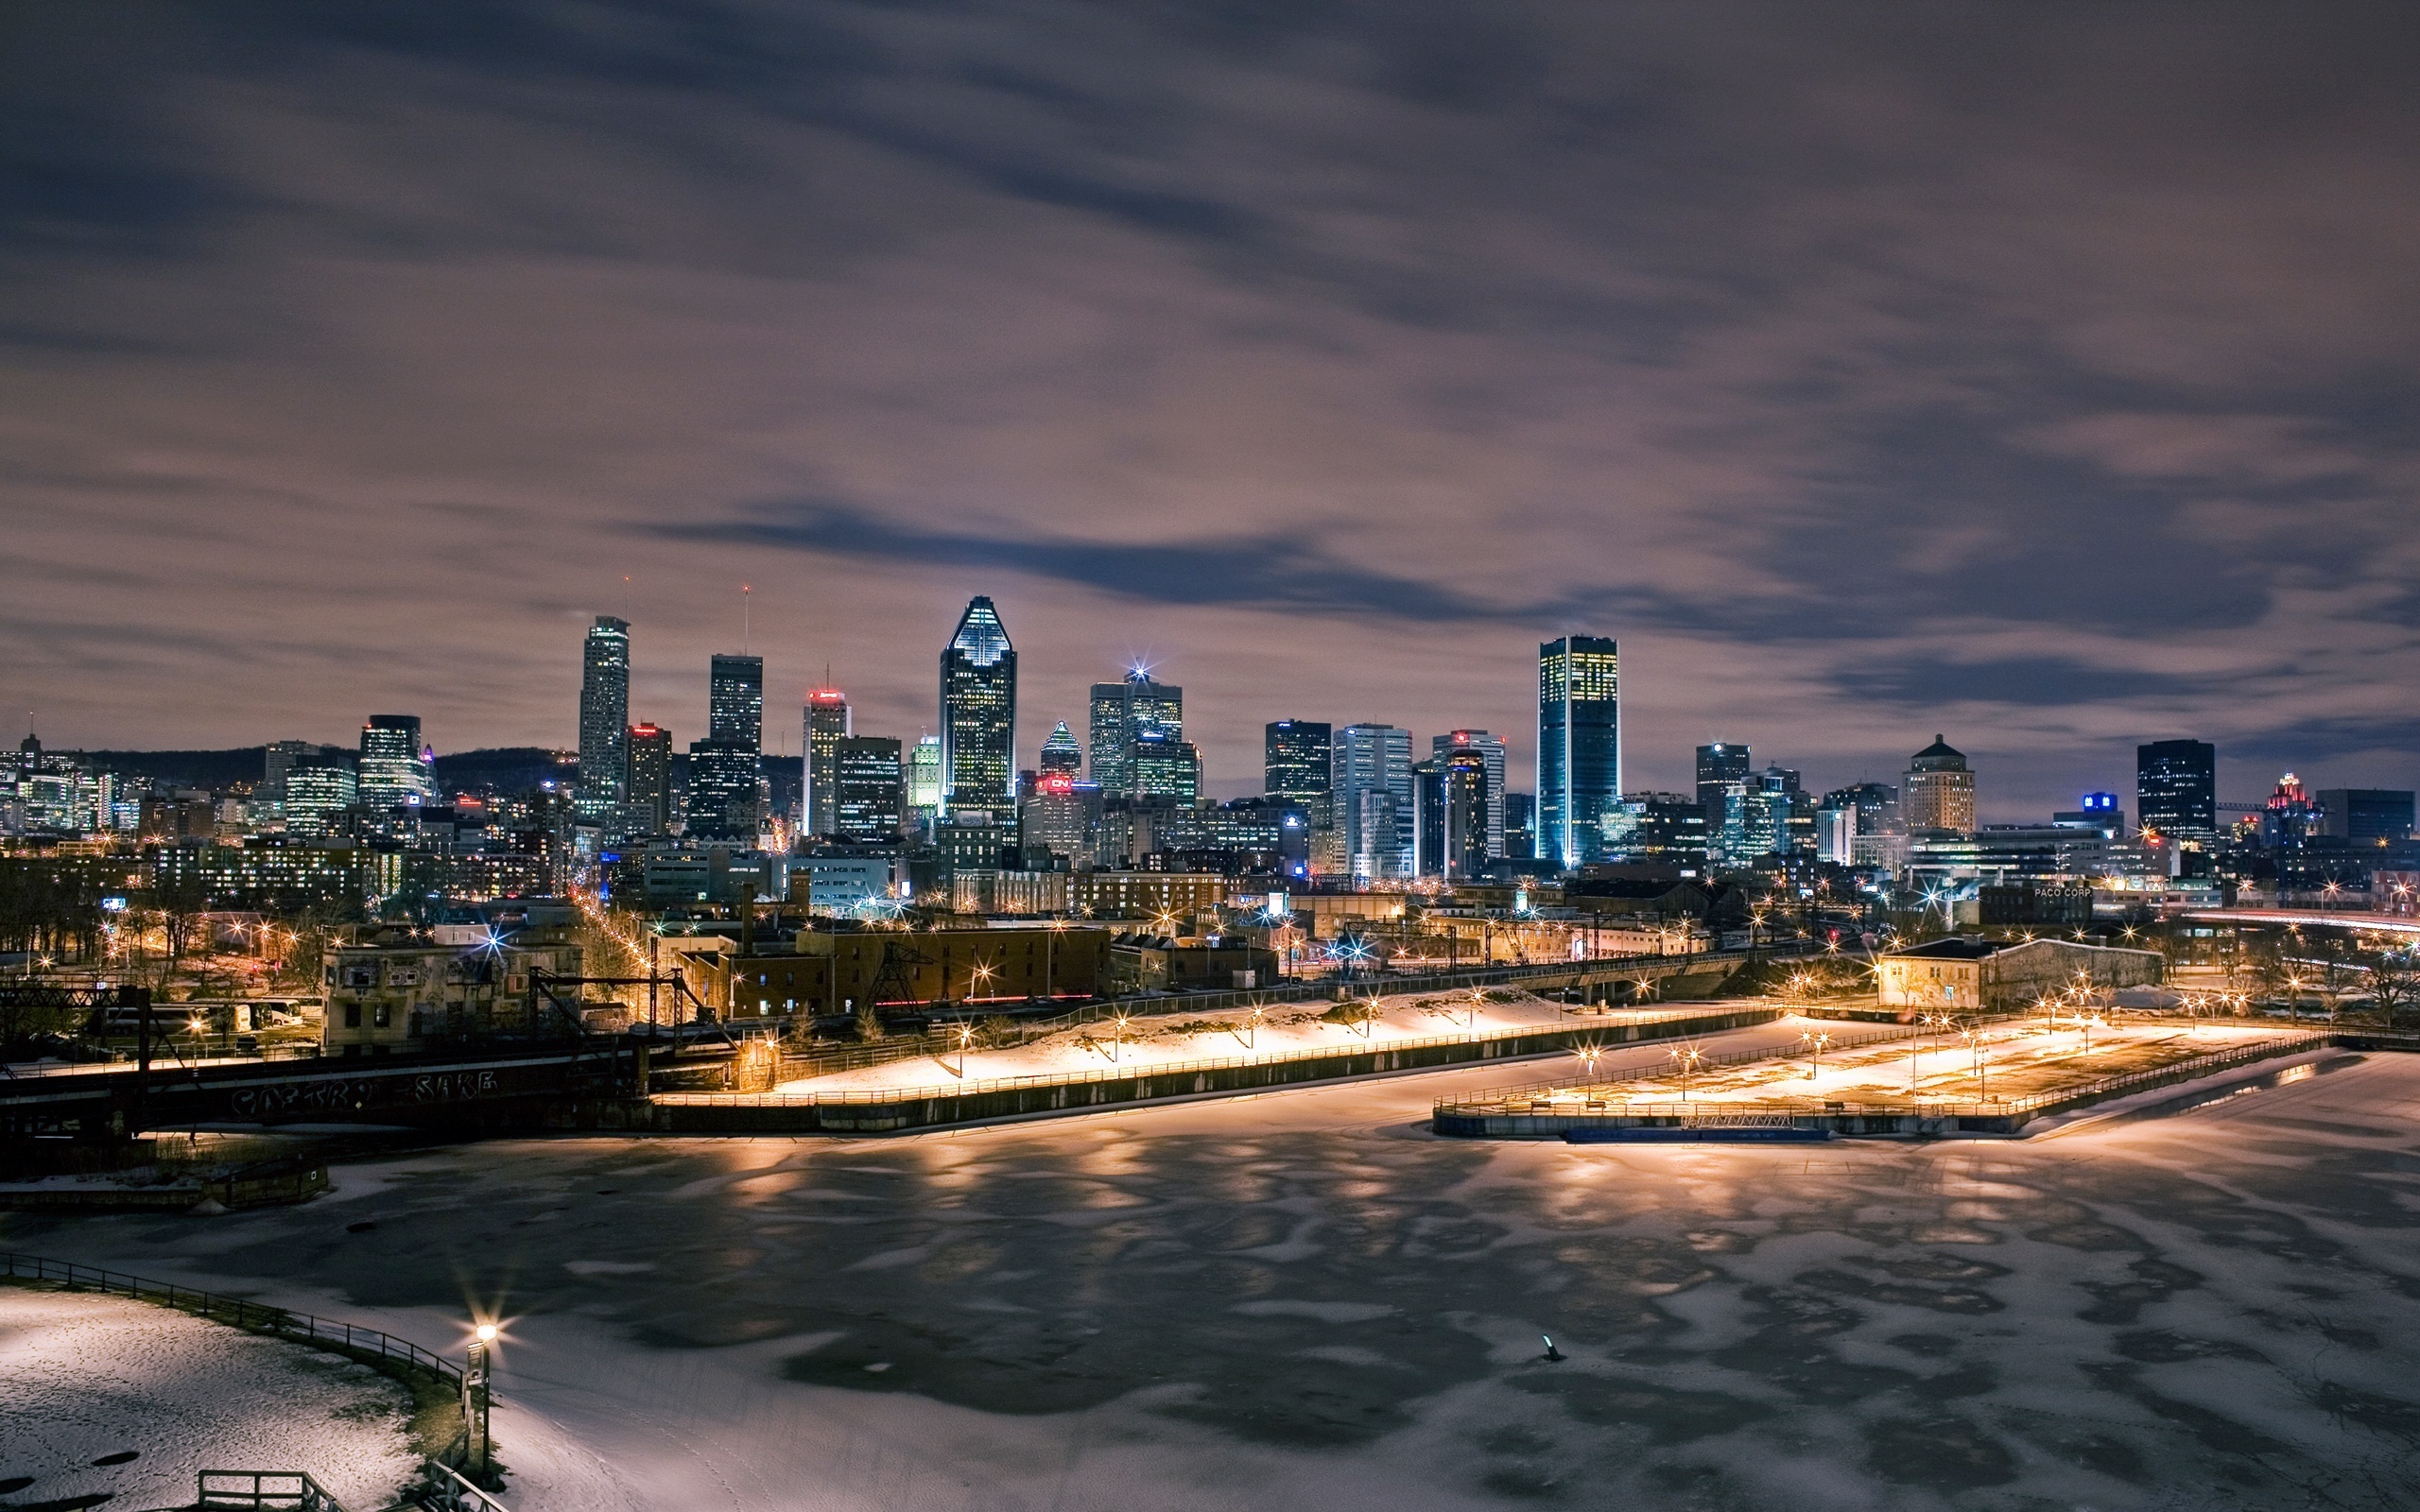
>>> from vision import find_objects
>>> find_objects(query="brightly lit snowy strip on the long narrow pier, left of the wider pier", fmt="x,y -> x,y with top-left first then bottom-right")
777,989 -> 1684,1096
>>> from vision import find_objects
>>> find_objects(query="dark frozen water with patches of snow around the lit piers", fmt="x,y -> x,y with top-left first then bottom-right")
0,1031 -> 2420,1512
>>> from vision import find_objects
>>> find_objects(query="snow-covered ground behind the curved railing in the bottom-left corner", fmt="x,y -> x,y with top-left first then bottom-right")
0,1284 -> 419,1512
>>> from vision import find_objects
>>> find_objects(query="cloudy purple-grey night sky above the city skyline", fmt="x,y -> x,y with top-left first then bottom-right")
0,0 -> 2420,817
